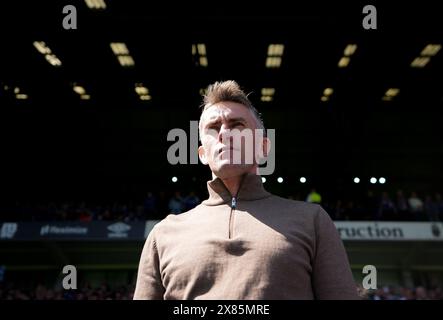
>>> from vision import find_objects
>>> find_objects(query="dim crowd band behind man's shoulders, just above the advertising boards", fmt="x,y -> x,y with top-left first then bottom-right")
0,189 -> 443,222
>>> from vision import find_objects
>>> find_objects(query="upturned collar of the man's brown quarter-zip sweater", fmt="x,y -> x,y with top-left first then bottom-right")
202,173 -> 271,206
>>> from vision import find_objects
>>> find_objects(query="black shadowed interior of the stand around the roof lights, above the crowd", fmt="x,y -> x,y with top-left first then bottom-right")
0,1 -> 443,204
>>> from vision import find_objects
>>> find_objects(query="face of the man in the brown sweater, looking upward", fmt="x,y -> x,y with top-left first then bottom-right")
198,101 -> 263,179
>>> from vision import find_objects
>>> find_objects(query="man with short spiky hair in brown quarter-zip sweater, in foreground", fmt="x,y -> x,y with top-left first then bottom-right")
134,81 -> 358,300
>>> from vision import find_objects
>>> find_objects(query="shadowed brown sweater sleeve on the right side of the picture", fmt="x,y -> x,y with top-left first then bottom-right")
312,206 -> 359,300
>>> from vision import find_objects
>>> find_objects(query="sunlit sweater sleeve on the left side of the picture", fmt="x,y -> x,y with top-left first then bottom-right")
134,228 -> 165,300
